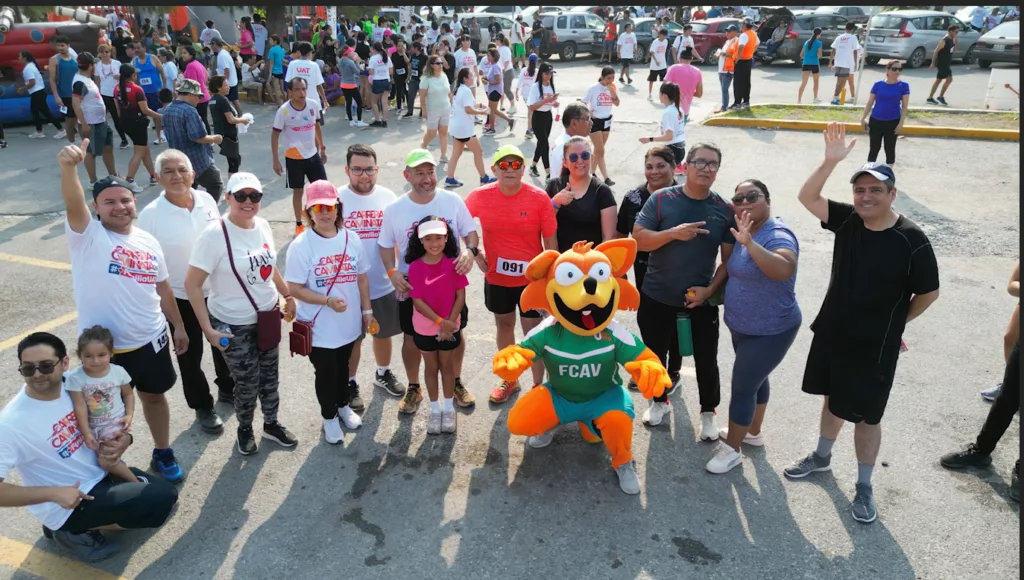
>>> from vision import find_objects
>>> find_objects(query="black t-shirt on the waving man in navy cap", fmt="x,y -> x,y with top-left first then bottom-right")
811,200 -> 939,355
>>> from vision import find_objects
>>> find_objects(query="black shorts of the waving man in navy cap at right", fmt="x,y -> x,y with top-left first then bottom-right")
803,334 -> 899,425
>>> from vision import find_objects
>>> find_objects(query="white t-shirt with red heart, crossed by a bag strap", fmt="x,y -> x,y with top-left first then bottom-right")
188,217 -> 279,325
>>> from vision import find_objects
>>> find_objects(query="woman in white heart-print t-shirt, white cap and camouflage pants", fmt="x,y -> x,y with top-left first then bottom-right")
185,171 -> 298,455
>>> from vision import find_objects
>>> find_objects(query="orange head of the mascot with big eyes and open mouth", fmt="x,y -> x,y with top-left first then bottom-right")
519,238 -> 640,336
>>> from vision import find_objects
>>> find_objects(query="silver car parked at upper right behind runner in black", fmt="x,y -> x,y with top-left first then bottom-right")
865,10 -> 981,69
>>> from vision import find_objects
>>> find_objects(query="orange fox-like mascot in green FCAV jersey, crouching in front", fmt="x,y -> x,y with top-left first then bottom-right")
494,238 -> 671,494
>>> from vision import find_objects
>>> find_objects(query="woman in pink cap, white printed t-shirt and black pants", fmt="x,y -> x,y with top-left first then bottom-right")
285,179 -> 376,445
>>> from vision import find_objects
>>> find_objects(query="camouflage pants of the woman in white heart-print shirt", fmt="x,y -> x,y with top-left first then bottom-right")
210,316 -> 281,426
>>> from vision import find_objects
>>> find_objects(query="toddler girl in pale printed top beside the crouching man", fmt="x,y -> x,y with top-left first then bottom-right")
65,325 -> 138,482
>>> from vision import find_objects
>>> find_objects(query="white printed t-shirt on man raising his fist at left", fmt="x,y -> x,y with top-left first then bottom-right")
65,219 -> 168,350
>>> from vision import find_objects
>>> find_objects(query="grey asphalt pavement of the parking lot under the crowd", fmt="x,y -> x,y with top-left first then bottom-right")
0,59 -> 1020,580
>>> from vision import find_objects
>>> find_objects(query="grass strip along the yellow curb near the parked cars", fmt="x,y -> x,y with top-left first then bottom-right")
723,105 -> 1020,130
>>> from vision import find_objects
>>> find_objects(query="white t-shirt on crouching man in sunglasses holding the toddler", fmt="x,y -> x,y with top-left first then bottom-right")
0,385 -> 106,530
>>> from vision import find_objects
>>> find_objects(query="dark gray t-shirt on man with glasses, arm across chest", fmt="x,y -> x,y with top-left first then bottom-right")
636,185 -> 736,306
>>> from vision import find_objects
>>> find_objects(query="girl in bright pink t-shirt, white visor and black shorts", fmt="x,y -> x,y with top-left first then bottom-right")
406,215 -> 469,434
